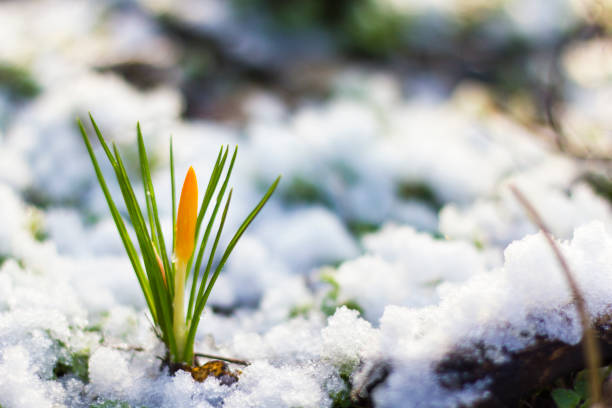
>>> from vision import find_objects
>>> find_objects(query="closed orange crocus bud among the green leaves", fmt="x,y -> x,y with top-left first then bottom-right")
174,167 -> 198,262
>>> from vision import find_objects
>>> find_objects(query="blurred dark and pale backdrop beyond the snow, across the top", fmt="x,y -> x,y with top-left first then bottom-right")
0,0 -> 612,142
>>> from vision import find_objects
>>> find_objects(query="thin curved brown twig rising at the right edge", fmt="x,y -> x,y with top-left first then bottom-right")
510,185 -> 601,406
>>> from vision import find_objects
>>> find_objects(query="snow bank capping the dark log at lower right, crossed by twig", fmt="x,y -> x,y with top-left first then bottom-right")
375,222 -> 612,407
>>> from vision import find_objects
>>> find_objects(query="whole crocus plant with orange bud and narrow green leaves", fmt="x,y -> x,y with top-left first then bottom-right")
78,115 -> 280,366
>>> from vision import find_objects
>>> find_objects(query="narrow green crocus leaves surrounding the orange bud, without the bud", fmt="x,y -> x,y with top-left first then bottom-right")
78,115 -> 280,364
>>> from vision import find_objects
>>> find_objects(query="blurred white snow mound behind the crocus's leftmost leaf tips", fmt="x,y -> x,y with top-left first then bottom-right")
6,73 -> 181,204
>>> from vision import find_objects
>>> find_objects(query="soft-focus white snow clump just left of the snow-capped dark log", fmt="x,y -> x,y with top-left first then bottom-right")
333,225 -> 486,322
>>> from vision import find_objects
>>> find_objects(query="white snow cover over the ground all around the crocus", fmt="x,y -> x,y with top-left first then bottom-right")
0,0 -> 612,408
